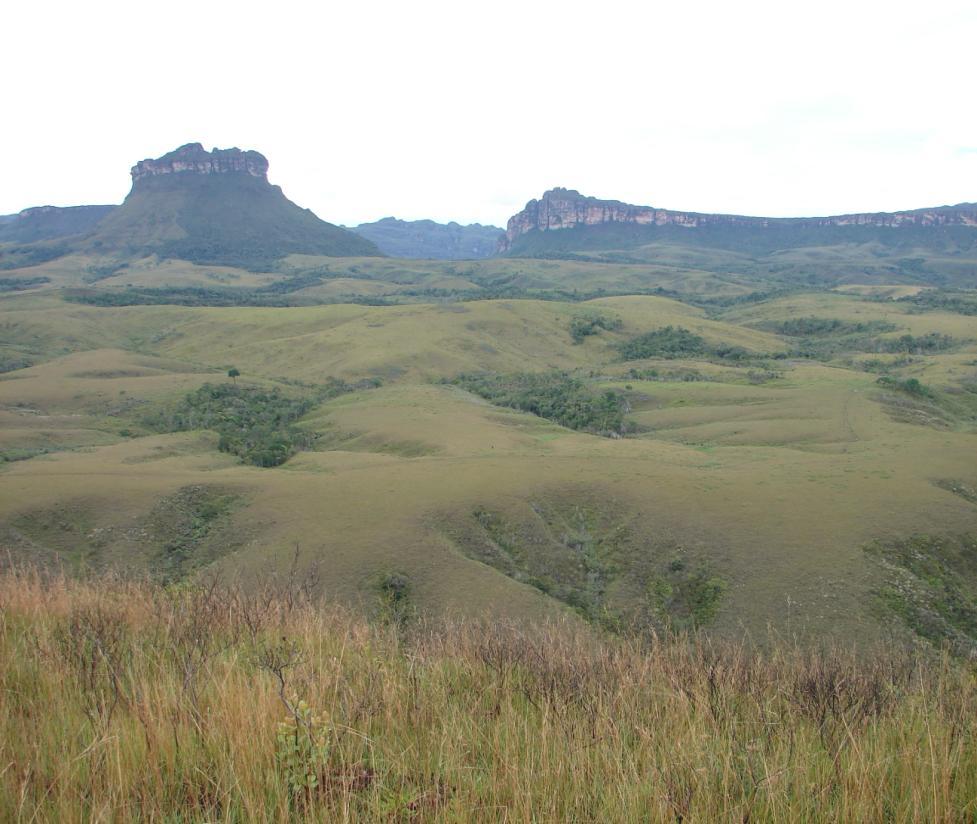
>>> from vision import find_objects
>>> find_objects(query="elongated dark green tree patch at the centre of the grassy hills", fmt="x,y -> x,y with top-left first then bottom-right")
451,372 -> 628,437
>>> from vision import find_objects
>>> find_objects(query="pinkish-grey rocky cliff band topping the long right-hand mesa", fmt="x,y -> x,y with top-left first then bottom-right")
499,188 -> 977,253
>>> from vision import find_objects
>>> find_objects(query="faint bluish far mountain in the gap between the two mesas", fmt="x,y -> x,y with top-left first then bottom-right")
352,217 -> 505,260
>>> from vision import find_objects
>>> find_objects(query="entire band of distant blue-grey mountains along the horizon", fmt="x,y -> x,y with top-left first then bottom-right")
0,148 -> 977,276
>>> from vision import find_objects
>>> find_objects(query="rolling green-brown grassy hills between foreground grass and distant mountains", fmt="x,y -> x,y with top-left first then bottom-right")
0,280 -> 977,650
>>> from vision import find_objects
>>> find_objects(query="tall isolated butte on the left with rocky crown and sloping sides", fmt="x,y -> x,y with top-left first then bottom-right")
86,143 -> 381,268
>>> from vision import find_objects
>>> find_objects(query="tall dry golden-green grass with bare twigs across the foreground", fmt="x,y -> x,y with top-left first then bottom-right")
0,571 -> 977,822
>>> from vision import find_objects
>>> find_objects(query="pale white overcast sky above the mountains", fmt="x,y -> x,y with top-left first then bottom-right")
0,0 -> 977,226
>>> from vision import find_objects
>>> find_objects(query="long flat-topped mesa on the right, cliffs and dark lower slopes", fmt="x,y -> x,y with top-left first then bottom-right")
499,188 -> 977,257
